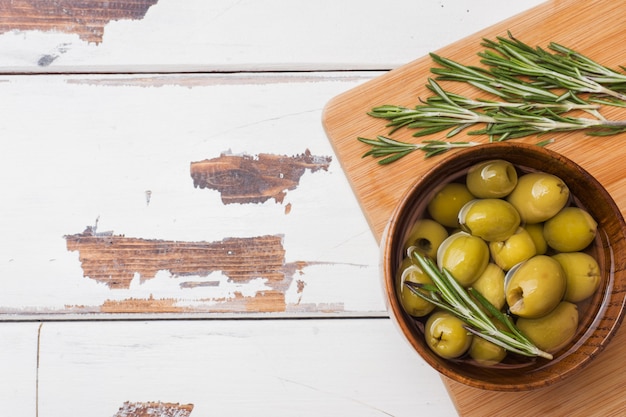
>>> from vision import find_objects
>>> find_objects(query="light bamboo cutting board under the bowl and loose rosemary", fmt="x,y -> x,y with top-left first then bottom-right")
323,0 -> 626,417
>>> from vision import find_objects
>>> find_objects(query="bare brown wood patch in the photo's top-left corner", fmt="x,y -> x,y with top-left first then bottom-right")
0,0 -> 158,44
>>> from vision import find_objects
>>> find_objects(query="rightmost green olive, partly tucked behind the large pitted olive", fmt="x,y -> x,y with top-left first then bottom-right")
552,252 -> 600,303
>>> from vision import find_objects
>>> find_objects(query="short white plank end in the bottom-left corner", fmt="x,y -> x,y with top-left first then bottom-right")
0,323 -> 39,417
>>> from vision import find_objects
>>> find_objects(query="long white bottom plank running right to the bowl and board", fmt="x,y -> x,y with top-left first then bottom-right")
39,319 -> 454,417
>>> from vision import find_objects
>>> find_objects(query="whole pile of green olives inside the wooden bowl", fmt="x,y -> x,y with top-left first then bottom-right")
396,159 -> 601,366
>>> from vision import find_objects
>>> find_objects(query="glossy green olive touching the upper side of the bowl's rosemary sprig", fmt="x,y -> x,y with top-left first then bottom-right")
437,232 -> 489,287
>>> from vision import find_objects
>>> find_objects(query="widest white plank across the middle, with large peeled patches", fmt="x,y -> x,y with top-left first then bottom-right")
0,73 -> 386,320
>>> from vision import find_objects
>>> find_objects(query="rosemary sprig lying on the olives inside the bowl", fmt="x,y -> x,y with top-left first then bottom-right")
405,248 -> 553,359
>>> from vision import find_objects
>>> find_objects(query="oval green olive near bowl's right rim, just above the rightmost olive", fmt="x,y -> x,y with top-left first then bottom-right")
543,207 -> 598,252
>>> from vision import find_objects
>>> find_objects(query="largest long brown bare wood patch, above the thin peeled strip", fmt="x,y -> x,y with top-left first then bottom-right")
65,226 -> 285,288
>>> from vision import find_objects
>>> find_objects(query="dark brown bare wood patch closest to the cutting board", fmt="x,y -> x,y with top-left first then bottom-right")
191,149 -> 332,205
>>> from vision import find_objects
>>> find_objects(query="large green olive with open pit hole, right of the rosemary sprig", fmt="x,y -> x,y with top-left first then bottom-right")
504,255 -> 566,318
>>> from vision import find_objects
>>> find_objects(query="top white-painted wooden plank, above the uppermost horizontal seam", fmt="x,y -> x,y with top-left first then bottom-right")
0,0 -> 540,73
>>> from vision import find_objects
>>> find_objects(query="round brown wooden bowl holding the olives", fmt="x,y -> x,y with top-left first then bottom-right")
381,142 -> 626,391
